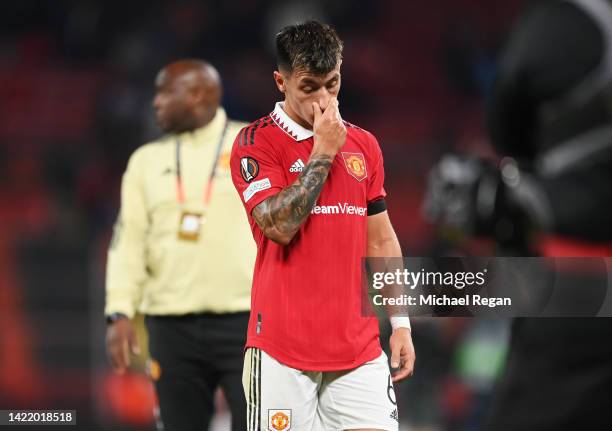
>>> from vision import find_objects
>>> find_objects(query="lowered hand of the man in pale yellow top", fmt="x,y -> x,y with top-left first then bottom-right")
106,318 -> 140,374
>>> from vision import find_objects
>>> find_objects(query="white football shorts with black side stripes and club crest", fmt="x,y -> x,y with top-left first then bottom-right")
242,348 -> 398,431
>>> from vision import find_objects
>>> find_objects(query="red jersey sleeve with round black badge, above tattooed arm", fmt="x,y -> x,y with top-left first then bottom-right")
230,129 -> 286,216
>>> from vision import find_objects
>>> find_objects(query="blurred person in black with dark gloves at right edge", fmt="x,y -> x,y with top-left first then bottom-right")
428,0 -> 612,431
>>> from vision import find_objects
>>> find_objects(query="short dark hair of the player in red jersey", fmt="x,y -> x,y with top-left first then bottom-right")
276,21 -> 344,75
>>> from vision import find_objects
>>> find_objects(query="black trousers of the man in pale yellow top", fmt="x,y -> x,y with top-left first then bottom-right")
145,312 -> 249,431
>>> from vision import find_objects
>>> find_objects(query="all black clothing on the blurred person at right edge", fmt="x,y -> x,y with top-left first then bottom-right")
484,0 -> 612,431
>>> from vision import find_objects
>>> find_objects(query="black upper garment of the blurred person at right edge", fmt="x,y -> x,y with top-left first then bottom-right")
488,0 -> 612,241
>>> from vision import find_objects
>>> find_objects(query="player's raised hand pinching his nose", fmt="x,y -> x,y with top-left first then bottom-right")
312,98 -> 346,159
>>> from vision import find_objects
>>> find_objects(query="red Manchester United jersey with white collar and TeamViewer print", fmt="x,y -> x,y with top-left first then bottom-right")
231,103 -> 386,371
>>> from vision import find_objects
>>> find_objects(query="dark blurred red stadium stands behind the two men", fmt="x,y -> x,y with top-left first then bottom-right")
0,0 -> 527,431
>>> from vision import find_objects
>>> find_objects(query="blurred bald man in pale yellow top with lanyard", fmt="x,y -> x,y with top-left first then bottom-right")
106,60 -> 255,431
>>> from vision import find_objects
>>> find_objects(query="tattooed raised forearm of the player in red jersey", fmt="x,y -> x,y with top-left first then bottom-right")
252,156 -> 333,245
